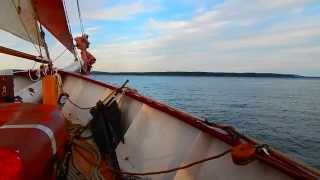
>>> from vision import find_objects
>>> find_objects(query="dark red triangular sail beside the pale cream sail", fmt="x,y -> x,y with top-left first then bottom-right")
33,0 -> 74,53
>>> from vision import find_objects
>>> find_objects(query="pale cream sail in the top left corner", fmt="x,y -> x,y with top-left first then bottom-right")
0,0 -> 43,45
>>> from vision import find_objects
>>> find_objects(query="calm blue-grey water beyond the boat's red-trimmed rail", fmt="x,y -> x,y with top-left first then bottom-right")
95,75 -> 320,168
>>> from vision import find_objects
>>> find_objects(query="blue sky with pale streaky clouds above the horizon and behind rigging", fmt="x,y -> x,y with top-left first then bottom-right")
0,0 -> 320,76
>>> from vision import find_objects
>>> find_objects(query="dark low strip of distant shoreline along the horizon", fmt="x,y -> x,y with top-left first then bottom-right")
91,71 -> 320,79
